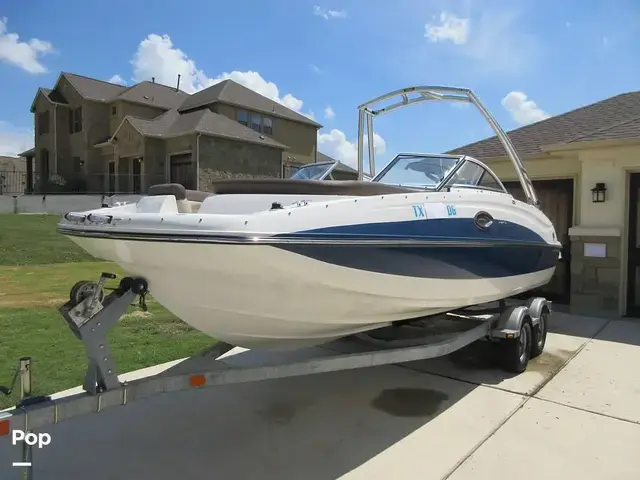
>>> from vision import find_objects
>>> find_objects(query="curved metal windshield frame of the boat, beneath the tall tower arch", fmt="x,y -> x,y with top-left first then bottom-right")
371,153 -> 509,194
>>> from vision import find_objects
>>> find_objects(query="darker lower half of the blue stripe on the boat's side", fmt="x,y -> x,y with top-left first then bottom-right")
274,244 -> 558,278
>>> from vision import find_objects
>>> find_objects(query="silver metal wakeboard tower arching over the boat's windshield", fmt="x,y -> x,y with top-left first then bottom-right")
357,86 -> 540,208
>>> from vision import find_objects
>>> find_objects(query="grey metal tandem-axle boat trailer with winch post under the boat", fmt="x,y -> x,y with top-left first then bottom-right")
0,272 -> 551,478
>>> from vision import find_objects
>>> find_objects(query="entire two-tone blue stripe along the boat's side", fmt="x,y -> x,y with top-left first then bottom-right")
274,218 -> 558,279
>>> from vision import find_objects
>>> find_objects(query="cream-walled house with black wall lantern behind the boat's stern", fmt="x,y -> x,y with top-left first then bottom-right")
449,91 -> 640,317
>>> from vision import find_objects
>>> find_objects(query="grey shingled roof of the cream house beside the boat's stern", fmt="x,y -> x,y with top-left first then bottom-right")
447,91 -> 640,159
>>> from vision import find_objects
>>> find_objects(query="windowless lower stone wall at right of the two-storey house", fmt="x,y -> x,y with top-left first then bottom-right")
199,136 -> 282,192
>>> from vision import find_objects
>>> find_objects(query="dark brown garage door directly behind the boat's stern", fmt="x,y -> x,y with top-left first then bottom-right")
504,180 -> 573,304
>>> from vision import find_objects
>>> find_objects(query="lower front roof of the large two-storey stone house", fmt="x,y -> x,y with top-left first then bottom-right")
114,108 -> 288,149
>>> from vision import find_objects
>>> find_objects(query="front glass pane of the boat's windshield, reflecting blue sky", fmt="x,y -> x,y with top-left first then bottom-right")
374,155 -> 460,187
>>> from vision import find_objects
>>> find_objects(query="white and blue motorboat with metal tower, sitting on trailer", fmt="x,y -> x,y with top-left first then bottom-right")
57,86 -> 561,349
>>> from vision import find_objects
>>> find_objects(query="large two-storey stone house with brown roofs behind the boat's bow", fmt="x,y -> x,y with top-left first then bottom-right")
23,72 -> 322,193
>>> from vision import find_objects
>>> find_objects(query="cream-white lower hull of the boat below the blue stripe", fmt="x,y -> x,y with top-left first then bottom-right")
71,236 -> 554,348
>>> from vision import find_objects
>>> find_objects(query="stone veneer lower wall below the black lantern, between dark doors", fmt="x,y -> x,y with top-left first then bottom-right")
571,236 -> 622,316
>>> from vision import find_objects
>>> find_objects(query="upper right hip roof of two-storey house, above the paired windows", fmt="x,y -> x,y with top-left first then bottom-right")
179,80 -> 322,128
